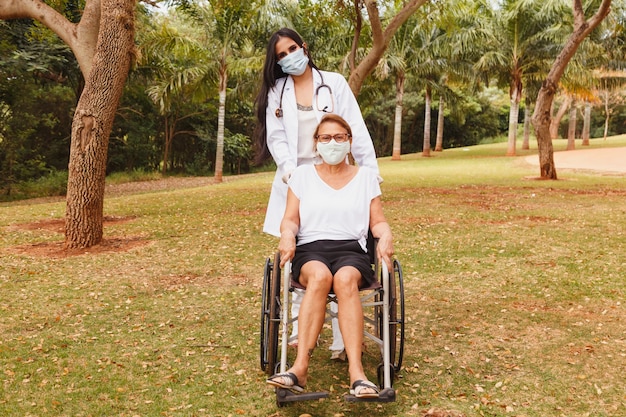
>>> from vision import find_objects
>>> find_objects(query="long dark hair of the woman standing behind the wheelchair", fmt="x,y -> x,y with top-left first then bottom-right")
252,28 -> 317,165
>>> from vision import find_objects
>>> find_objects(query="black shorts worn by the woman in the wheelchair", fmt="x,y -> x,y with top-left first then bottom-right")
291,240 -> 375,288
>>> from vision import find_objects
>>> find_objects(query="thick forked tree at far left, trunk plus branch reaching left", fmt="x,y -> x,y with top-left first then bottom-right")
0,0 -> 135,248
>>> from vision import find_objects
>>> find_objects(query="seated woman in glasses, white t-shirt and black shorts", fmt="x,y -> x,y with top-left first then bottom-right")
267,114 -> 393,398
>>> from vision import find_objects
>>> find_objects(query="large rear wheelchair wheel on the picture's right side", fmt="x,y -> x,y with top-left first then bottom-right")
389,260 -> 405,375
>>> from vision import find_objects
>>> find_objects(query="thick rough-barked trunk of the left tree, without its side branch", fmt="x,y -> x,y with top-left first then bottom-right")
64,0 -> 135,248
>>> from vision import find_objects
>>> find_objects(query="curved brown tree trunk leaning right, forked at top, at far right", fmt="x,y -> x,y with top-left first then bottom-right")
532,0 -> 611,179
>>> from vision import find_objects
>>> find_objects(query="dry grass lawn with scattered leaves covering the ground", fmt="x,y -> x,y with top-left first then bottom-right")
0,137 -> 626,417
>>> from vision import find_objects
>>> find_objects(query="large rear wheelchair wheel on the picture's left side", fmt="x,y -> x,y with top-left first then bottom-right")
260,254 -> 280,375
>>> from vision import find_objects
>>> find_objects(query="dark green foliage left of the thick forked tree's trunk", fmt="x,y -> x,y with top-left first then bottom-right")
0,20 -> 76,192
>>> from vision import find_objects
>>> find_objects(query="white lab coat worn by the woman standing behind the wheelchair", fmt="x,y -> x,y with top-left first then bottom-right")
263,69 -> 382,236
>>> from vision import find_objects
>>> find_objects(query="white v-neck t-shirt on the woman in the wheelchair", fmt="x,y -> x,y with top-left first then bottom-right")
289,165 -> 381,250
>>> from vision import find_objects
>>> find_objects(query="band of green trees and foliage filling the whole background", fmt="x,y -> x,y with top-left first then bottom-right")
0,0 -> 625,185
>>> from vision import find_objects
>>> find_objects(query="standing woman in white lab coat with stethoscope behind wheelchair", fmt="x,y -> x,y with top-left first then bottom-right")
254,28 -> 382,360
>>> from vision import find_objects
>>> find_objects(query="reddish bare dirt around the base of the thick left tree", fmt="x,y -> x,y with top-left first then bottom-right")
8,216 -> 150,258
